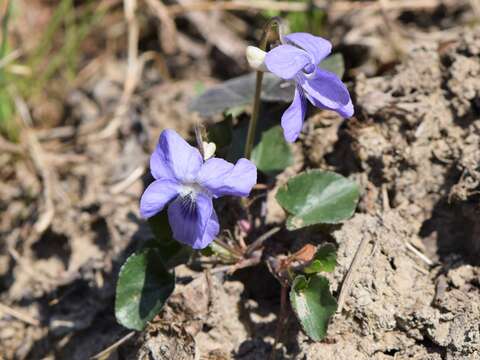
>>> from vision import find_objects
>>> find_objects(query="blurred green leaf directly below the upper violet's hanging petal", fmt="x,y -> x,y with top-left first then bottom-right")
252,125 -> 293,174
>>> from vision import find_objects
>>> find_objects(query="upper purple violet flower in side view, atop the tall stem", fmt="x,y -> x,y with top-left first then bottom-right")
265,33 -> 353,142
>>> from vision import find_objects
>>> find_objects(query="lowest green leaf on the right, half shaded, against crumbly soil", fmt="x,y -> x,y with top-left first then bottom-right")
290,275 -> 337,341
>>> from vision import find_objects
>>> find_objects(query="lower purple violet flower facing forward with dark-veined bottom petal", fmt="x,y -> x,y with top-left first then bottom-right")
140,129 -> 257,249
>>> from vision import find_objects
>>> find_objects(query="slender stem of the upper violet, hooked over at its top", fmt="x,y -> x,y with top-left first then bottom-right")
245,17 -> 282,159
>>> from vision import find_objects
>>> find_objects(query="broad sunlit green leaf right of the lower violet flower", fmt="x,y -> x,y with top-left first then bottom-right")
276,170 -> 359,230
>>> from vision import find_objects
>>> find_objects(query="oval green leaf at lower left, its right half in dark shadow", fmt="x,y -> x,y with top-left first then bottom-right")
115,249 -> 175,331
